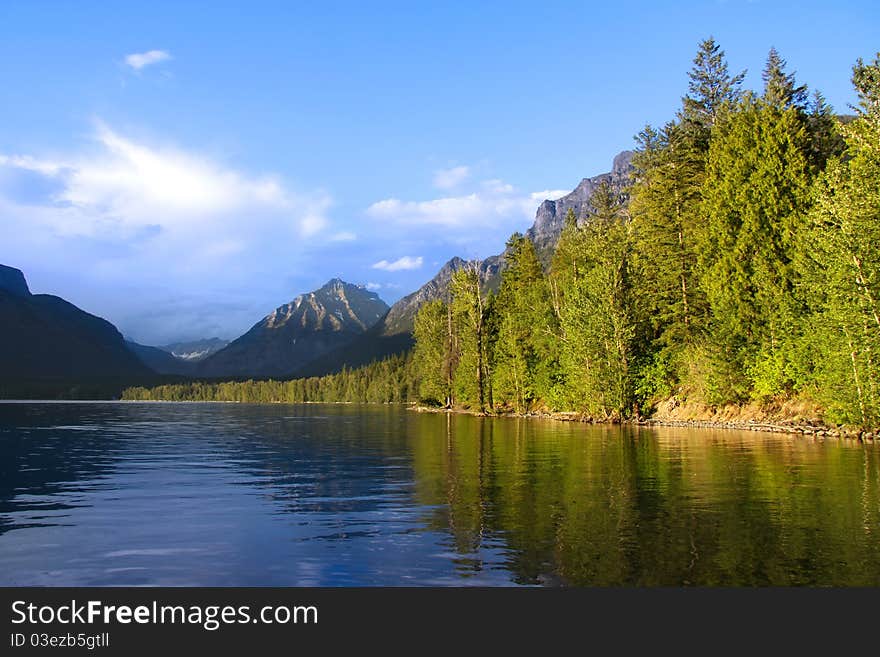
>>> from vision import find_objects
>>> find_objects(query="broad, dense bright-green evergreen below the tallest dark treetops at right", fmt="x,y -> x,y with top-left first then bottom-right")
698,92 -> 810,402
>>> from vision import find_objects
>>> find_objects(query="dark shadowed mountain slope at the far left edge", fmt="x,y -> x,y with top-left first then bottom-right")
0,265 -> 154,383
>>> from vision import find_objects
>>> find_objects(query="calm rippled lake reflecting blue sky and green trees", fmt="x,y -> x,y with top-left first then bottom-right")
0,403 -> 880,586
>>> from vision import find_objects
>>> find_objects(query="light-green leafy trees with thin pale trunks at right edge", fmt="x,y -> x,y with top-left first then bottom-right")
798,55 -> 880,427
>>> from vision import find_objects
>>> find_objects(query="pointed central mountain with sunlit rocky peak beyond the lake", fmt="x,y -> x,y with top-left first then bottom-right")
203,278 -> 388,377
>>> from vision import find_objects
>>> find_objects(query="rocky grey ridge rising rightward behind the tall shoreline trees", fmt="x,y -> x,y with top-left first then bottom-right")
297,151 -> 633,376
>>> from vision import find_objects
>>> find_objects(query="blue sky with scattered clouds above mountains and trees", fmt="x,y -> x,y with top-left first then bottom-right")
0,0 -> 880,344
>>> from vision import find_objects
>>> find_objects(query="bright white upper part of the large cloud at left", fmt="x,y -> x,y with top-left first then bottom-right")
0,125 -> 331,237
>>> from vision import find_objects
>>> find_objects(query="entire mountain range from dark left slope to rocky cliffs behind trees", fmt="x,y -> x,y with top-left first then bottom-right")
0,151 -> 632,382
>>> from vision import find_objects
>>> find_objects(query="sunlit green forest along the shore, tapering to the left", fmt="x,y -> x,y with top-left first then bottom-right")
124,39 -> 880,436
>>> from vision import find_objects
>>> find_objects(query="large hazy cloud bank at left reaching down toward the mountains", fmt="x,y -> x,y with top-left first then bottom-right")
0,124 -> 339,338
